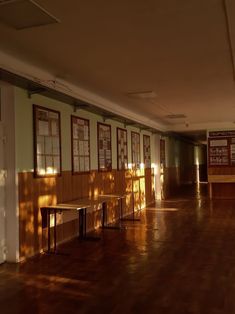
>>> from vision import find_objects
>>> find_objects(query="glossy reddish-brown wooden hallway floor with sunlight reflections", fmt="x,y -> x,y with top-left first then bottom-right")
0,185 -> 235,314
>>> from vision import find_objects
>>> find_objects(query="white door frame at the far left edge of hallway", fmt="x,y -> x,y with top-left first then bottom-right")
0,81 -> 19,263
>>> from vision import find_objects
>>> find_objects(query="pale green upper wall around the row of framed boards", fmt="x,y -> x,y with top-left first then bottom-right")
15,87 -> 155,172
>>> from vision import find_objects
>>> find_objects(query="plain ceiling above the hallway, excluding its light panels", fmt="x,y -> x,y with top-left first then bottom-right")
0,0 -> 235,137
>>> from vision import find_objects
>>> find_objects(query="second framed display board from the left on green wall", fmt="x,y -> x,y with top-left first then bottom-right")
71,116 -> 90,174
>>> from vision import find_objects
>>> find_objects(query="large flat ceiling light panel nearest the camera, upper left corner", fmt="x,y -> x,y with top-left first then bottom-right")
0,0 -> 60,30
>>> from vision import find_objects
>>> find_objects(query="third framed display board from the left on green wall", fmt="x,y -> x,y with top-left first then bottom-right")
97,122 -> 112,171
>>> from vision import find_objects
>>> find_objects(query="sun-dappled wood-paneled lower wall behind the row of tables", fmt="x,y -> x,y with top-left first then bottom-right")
18,169 -> 155,259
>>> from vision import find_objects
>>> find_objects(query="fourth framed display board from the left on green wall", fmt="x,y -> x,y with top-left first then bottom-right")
117,128 -> 128,170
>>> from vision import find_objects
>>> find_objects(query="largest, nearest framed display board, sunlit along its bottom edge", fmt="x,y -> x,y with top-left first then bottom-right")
33,105 -> 61,177
